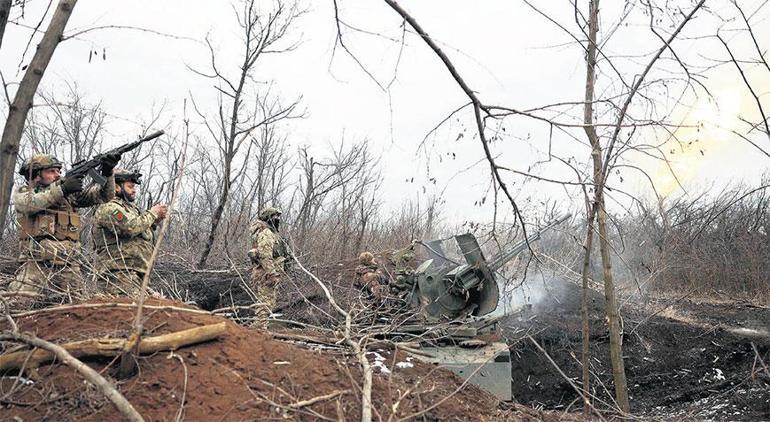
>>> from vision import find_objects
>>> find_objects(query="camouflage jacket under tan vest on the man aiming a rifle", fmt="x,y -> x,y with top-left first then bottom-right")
11,177 -> 115,263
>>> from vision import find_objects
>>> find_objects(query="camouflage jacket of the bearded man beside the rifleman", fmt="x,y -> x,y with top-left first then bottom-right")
93,198 -> 158,273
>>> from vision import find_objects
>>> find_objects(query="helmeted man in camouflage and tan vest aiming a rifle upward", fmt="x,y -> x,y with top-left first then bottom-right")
9,154 -> 120,302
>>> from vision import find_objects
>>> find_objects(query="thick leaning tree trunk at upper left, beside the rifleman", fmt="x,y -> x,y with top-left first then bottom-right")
0,0 -> 77,238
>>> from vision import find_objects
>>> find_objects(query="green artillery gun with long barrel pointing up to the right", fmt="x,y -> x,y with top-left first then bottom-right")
399,214 -> 571,400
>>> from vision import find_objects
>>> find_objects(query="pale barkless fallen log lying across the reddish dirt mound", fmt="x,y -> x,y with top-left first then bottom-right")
0,322 -> 227,372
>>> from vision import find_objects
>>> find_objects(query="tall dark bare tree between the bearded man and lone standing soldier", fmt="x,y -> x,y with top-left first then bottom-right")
193,0 -> 301,267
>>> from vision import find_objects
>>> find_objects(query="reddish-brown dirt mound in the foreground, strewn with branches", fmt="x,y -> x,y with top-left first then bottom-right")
0,300 -> 568,420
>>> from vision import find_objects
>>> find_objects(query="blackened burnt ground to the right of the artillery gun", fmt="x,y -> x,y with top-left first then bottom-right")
506,283 -> 770,420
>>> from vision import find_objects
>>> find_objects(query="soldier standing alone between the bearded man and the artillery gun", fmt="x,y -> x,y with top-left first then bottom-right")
249,207 -> 289,328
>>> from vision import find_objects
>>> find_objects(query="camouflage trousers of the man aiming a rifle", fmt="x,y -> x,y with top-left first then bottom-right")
8,261 -> 87,304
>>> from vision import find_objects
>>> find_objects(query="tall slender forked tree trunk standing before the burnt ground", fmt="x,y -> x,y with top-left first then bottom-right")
582,0 -> 631,413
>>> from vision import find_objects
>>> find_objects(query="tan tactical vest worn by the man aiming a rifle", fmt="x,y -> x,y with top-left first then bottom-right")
17,195 -> 80,242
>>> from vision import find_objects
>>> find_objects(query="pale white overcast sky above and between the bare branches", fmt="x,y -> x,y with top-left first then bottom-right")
0,0 -> 770,226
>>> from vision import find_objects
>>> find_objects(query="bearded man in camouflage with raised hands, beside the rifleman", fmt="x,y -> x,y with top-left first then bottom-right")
93,169 -> 168,296
